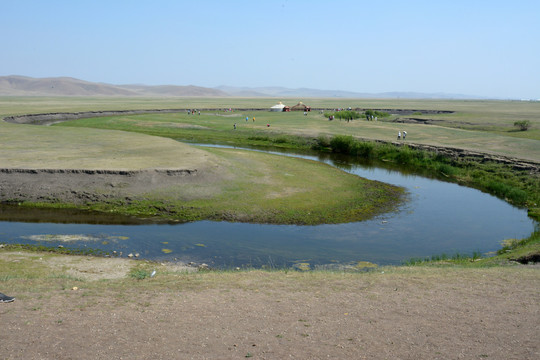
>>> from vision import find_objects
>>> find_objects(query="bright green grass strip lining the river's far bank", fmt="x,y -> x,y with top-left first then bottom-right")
49,111 -> 540,215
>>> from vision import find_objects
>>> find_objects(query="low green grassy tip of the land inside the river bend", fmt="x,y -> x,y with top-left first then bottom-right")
79,149 -> 402,224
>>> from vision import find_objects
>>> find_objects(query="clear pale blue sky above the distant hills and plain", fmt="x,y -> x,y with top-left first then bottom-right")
0,0 -> 540,99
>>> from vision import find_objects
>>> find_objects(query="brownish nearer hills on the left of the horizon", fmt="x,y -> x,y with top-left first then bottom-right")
0,75 -> 228,97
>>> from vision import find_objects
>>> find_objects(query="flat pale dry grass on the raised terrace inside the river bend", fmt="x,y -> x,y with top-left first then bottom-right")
0,123 -> 219,170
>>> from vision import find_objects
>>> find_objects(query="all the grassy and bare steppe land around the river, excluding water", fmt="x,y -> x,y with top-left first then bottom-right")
0,80 -> 540,359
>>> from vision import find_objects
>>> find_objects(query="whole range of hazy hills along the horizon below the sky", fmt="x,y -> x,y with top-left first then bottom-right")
0,75 -> 482,99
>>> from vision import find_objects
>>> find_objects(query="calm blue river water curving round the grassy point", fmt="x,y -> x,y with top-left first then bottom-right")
0,146 -> 535,267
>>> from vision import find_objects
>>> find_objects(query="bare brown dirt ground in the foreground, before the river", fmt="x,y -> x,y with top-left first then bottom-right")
0,253 -> 540,359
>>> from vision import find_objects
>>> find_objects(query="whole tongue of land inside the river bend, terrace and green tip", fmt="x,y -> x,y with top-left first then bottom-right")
0,139 -> 404,224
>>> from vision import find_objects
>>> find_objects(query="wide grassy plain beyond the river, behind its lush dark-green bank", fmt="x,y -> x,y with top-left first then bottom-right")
0,97 -> 540,161
